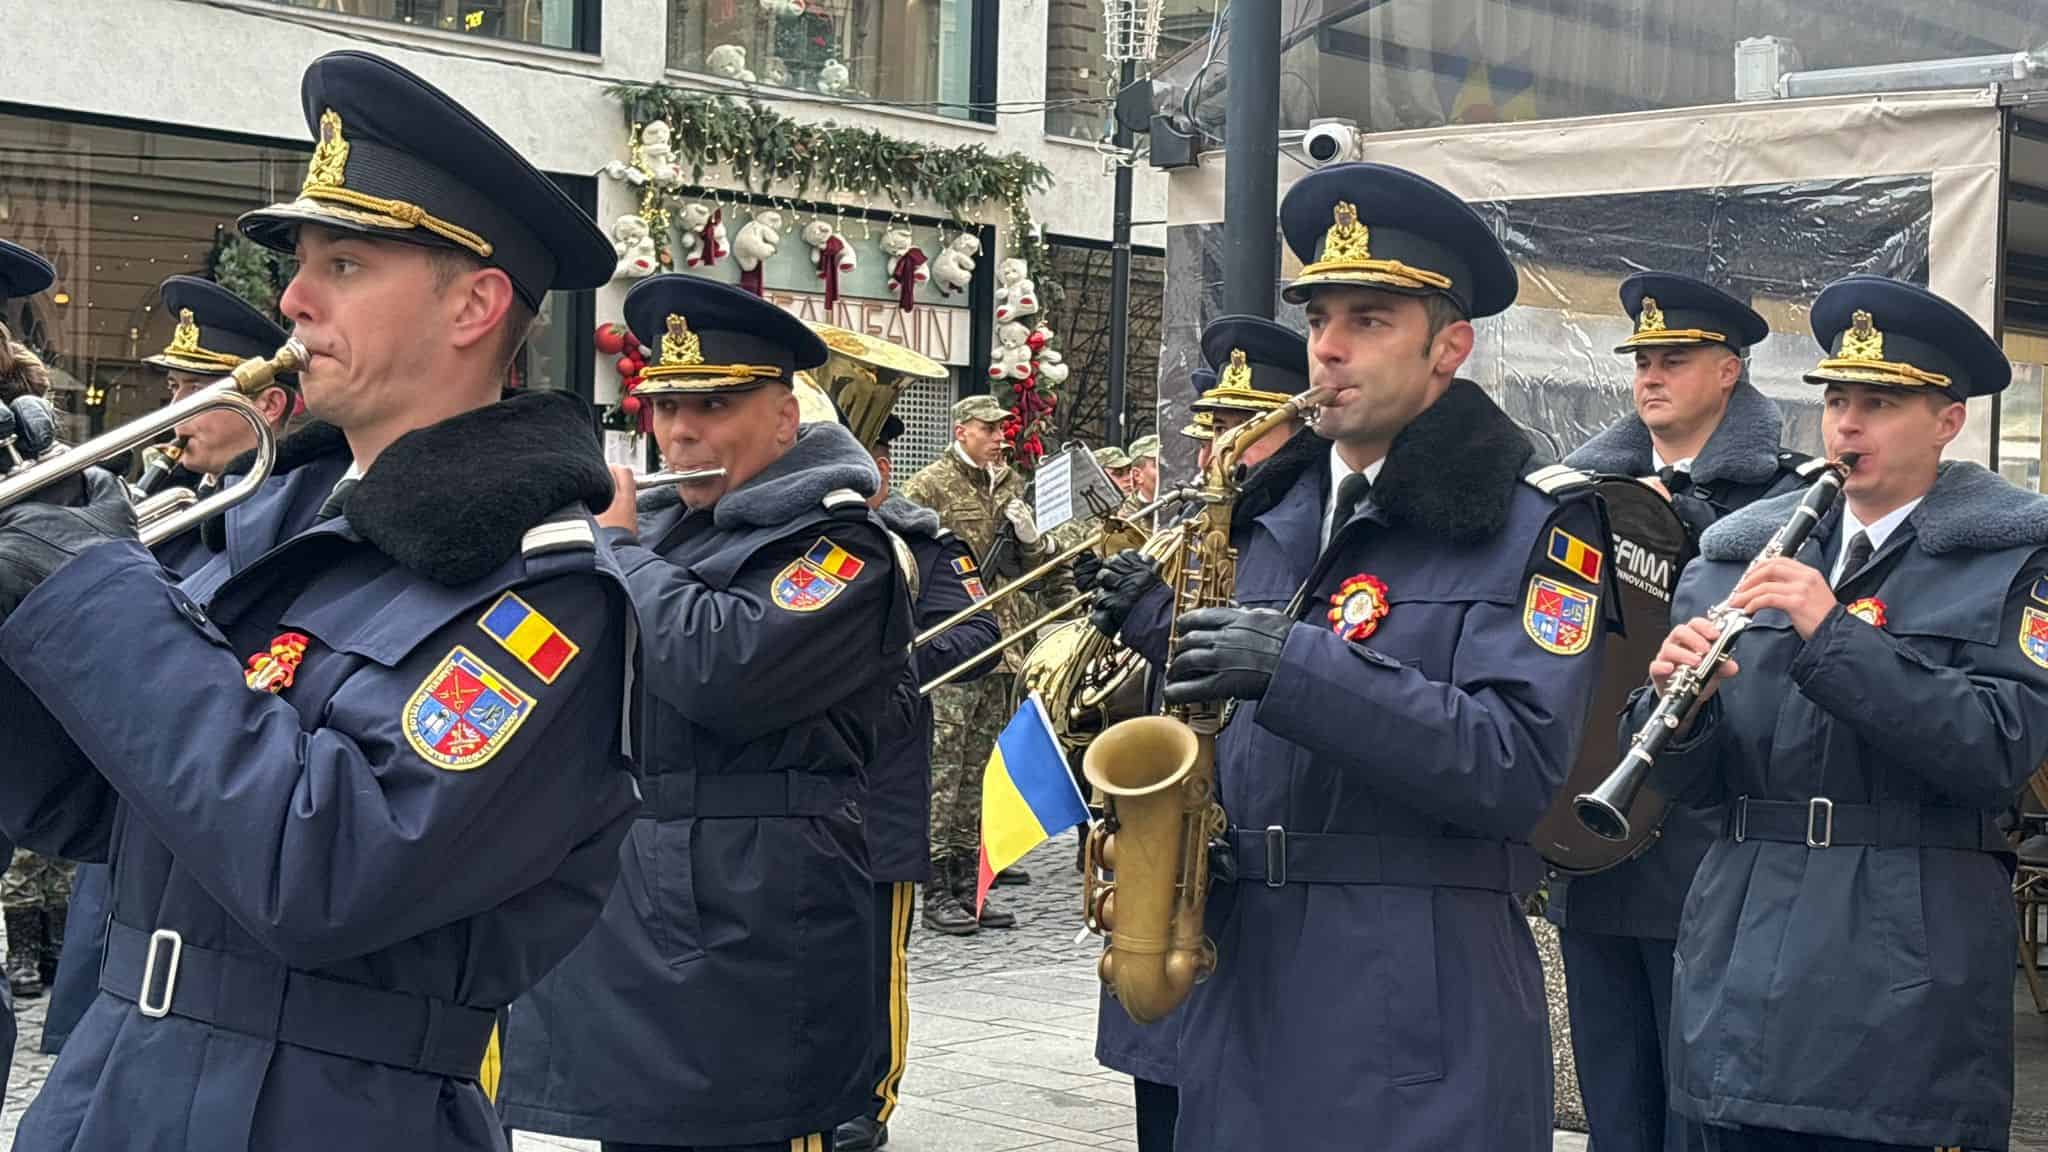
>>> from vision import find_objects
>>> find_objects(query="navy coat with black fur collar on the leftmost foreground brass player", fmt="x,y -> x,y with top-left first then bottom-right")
0,394 -> 635,1152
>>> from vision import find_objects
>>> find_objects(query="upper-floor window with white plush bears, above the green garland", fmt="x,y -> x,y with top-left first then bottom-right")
668,0 -> 993,119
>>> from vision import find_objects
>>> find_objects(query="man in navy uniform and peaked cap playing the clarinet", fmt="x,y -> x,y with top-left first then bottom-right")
1624,277 -> 2048,1152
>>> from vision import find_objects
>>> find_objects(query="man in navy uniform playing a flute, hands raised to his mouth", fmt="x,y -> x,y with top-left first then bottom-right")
502,275 -> 911,1152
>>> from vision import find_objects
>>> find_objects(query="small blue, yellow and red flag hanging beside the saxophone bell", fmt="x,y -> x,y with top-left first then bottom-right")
975,693 -> 1087,914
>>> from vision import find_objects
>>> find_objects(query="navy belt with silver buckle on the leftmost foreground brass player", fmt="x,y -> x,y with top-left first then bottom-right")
100,920 -> 498,1080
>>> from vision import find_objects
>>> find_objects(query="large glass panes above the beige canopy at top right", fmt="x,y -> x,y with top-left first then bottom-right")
1165,0 -> 2044,135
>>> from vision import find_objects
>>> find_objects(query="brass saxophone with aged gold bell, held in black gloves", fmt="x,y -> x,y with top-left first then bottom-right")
1081,389 -> 1323,1025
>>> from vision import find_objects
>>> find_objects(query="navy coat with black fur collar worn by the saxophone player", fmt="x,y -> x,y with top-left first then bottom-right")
1178,381 -> 1608,1152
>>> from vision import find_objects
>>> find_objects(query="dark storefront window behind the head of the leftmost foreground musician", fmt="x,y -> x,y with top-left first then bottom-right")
0,115 -> 594,441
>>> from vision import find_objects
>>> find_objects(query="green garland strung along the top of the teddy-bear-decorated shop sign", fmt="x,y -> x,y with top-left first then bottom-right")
606,84 -> 1063,307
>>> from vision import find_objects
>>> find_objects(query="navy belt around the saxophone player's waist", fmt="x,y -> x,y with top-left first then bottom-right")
1231,824 -> 1542,892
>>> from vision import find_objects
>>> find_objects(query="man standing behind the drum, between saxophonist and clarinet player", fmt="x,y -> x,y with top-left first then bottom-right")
1548,273 -> 1806,1152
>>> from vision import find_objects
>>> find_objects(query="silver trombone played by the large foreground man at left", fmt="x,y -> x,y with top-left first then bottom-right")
0,336 -> 307,547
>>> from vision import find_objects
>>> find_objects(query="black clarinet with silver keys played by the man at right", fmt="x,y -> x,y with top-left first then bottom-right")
1571,453 -> 1858,840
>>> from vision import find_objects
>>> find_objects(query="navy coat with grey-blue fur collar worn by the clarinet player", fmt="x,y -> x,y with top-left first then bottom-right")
1624,461 -> 2048,1150
